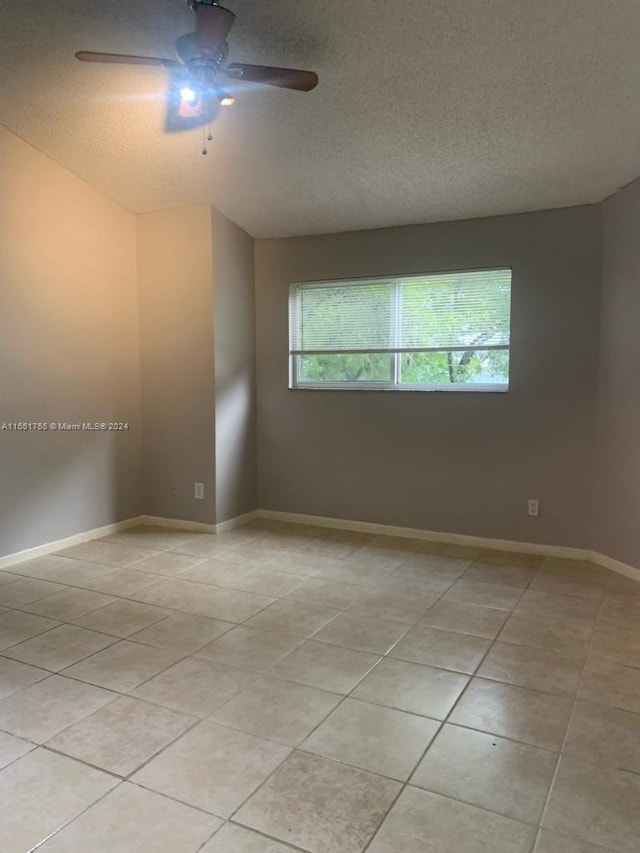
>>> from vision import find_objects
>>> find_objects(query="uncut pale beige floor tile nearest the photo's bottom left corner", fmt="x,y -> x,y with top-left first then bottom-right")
47,696 -> 196,776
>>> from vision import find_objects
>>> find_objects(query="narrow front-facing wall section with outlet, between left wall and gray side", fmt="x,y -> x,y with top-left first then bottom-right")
137,205 -> 216,524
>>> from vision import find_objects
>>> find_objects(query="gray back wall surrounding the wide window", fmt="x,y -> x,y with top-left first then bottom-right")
256,206 -> 601,547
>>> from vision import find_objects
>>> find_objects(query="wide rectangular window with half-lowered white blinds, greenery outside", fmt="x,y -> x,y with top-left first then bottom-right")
289,269 -> 511,391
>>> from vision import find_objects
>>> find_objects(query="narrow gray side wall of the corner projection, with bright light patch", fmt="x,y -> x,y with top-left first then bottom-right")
212,210 -> 257,522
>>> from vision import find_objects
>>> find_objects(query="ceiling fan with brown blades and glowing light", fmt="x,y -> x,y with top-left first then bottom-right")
76,0 -> 318,126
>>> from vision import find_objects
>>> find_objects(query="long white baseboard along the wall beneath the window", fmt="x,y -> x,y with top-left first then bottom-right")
258,509 -> 591,560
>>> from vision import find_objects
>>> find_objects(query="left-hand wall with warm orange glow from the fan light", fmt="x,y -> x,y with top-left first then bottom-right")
0,127 -> 140,555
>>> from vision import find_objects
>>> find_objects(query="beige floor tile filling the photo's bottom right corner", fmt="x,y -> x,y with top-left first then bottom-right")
543,757 -> 640,853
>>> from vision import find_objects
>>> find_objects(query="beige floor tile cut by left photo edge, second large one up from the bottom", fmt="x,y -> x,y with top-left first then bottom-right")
0,675 -> 117,744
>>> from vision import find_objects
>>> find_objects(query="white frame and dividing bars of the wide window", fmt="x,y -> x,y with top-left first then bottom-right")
287,264 -> 513,394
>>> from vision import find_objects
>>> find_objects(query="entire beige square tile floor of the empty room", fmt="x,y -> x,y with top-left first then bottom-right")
0,522 -> 640,853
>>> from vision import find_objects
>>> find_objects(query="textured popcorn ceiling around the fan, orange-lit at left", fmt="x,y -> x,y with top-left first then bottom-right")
0,0 -> 640,237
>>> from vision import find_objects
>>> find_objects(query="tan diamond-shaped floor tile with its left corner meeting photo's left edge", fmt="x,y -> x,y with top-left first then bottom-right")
4,625 -> 116,672
